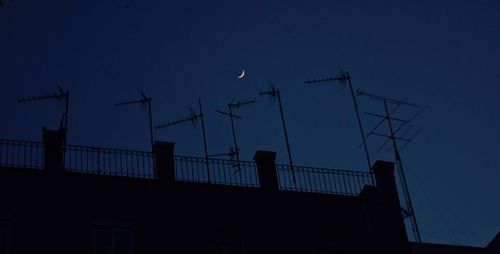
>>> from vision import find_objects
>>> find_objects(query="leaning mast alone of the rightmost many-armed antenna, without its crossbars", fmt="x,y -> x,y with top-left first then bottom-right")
384,100 -> 422,243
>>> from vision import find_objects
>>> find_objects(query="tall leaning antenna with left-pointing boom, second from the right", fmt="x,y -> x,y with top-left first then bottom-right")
304,67 -> 373,178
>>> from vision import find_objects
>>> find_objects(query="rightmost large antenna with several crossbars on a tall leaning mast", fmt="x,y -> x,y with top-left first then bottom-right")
356,90 -> 425,242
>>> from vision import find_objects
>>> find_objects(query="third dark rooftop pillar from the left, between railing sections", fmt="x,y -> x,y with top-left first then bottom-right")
253,151 -> 279,191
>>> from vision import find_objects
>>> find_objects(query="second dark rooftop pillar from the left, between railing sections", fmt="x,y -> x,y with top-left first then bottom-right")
153,141 -> 175,185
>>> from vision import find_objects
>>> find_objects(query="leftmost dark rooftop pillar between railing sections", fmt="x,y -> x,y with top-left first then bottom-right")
43,128 -> 65,174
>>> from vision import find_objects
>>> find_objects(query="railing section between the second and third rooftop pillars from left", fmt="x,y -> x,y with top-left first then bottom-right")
175,156 -> 259,188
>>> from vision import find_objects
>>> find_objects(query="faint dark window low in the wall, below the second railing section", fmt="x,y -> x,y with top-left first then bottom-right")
94,227 -> 134,254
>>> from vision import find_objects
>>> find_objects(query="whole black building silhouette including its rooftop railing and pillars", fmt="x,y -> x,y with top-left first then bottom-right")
0,130 -> 500,254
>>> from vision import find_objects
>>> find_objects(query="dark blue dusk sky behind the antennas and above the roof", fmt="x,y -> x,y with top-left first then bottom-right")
0,0 -> 500,246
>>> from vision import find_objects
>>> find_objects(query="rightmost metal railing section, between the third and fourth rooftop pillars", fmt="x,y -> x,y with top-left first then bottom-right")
276,164 -> 373,196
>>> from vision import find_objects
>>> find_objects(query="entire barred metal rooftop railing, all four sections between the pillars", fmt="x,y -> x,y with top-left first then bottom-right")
0,139 -> 374,196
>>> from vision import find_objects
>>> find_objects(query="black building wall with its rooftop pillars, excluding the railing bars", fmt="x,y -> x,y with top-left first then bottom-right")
0,130 -> 416,253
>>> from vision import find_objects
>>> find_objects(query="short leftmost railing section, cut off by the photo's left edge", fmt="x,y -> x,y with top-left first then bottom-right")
0,139 -> 45,169
